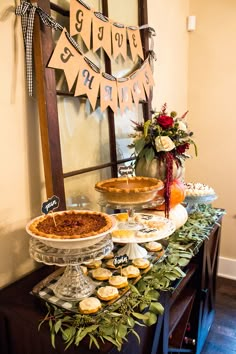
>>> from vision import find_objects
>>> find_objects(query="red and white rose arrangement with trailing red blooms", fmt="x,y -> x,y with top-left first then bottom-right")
129,103 -> 197,212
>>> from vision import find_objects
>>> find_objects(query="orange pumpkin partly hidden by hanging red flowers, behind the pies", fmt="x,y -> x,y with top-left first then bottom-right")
156,179 -> 185,210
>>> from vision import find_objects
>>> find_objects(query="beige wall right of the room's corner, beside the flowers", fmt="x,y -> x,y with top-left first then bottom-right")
187,0 -> 236,260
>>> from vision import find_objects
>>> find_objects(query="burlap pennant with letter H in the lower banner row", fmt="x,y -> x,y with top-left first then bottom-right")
75,60 -> 101,110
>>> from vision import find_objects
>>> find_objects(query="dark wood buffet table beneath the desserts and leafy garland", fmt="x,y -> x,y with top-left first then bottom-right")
0,207 -> 223,354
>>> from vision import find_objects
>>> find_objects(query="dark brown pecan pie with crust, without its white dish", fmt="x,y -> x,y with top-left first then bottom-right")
28,210 -> 112,239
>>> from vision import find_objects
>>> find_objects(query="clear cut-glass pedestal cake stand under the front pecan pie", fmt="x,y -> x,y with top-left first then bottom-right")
29,234 -> 113,301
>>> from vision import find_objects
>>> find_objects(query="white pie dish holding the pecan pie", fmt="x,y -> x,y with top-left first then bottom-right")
26,210 -> 117,249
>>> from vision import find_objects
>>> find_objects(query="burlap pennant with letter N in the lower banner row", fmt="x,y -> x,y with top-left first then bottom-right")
117,78 -> 133,113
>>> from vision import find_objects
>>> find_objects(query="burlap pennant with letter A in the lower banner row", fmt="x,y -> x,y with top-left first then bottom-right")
100,76 -> 117,113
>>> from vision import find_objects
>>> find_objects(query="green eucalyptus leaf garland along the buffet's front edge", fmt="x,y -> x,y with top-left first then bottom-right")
39,205 -> 224,351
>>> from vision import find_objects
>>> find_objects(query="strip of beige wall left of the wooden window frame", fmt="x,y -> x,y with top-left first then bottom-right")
0,0 -> 43,287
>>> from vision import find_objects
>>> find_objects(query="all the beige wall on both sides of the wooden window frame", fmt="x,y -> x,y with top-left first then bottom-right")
0,0 -> 236,287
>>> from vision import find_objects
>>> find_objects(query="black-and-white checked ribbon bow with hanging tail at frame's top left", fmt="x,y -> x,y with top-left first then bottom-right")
15,0 -> 63,96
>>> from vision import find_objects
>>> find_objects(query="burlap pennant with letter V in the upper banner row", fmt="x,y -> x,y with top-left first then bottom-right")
111,24 -> 127,60
